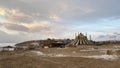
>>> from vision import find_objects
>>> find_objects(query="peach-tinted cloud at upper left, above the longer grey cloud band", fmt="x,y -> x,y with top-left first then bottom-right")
0,8 -> 34,23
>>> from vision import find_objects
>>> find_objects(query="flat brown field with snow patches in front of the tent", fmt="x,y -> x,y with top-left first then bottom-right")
0,45 -> 120,68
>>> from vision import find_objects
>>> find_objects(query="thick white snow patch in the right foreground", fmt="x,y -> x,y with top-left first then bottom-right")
81,55 -> 118,60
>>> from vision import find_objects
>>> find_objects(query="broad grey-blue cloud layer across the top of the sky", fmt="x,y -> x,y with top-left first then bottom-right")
0,0 -> 120,21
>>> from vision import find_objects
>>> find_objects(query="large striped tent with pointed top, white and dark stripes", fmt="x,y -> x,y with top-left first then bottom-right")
71,33 -> 92,46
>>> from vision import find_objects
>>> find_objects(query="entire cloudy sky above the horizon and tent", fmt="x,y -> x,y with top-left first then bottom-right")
0,0 -> 120,43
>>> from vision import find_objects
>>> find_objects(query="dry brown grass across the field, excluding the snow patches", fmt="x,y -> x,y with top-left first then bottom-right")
0,46 -> 120,68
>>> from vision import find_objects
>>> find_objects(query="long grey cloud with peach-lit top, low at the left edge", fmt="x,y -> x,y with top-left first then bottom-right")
0,21 -> 54,33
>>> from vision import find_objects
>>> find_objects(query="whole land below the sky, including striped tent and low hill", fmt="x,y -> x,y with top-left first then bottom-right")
0,33 -> 120,68
